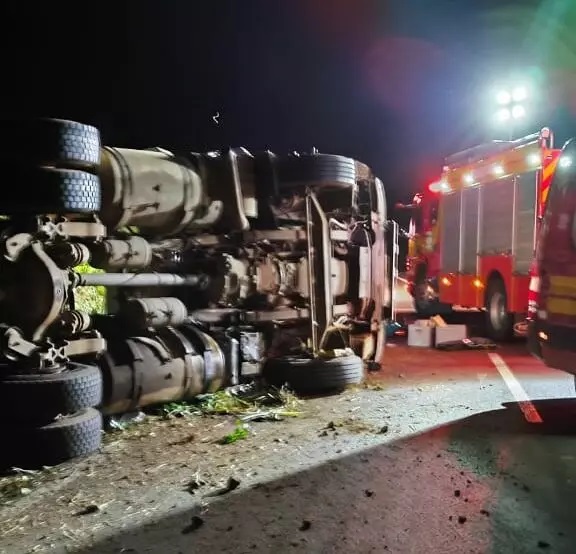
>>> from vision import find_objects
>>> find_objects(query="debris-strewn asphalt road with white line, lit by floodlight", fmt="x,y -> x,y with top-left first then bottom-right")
0,338 -> 576,554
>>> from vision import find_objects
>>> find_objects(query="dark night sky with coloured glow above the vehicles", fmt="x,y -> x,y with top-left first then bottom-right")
0,0 -> 576,205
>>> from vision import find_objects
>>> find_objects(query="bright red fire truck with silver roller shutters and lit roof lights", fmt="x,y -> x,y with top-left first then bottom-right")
405,128 -> 561,341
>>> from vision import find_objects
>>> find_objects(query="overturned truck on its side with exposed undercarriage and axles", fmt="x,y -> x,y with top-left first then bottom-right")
0,119 -> 391,465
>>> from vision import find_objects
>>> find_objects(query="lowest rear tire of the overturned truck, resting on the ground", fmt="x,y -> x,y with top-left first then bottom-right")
0,408 -> 103,469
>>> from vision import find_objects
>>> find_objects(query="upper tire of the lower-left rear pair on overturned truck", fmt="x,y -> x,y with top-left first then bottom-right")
0,362 -> 102,422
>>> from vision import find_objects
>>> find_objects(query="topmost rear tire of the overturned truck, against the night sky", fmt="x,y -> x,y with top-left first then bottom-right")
0,119 -> 100,169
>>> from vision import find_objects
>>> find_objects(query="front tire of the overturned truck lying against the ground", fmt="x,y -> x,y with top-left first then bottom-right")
262,356 -> 364,394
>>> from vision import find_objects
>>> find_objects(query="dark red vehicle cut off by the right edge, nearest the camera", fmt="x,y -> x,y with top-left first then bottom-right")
536,139 -> 576,373
